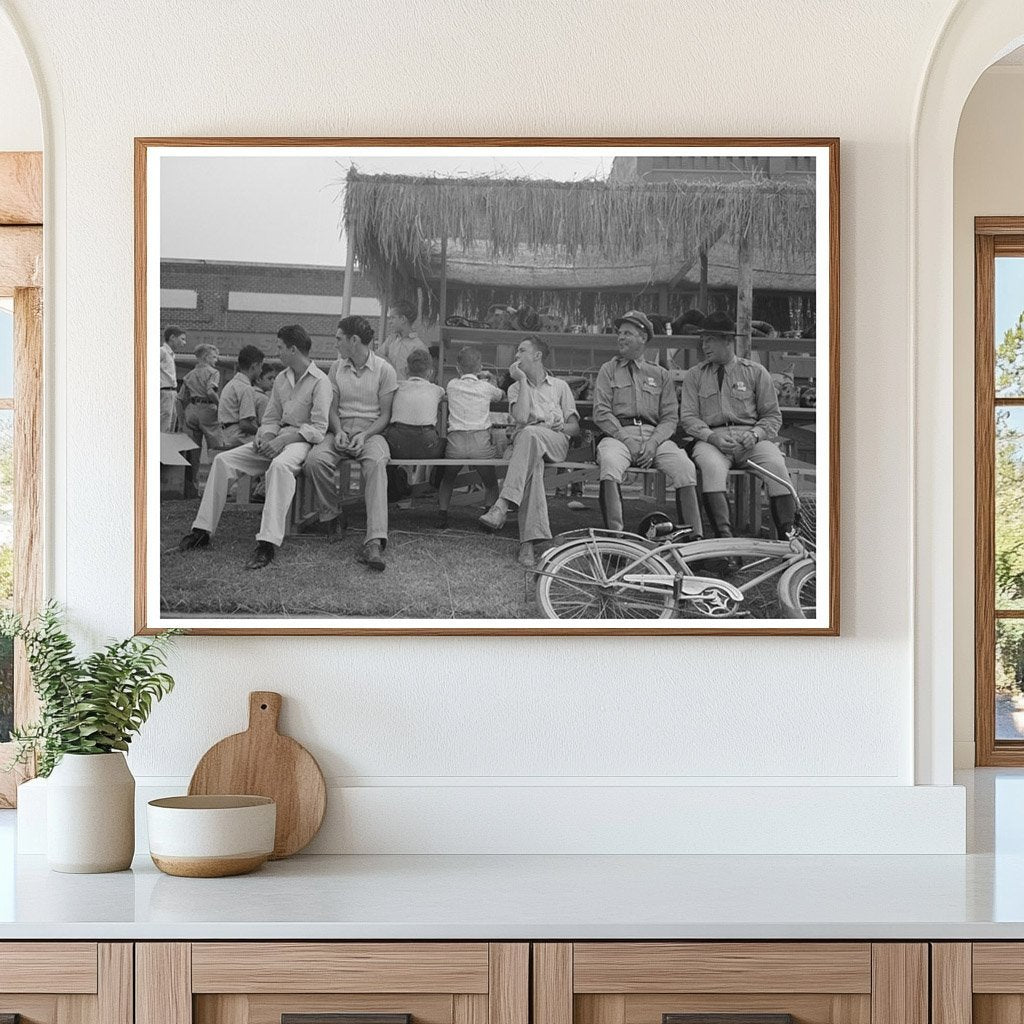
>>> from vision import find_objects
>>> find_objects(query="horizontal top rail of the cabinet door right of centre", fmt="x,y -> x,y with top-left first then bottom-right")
572,942 -> 871,994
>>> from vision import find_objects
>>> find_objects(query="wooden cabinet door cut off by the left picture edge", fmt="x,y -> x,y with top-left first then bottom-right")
0,942 -> 132,1024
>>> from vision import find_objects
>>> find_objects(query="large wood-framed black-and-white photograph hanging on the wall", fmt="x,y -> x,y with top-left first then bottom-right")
135,138 -> 839,635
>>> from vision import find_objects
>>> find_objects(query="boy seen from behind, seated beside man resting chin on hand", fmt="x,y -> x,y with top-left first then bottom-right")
437,346 -> 505,529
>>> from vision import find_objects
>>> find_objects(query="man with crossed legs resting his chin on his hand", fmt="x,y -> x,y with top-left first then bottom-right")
480,338 -> 580,568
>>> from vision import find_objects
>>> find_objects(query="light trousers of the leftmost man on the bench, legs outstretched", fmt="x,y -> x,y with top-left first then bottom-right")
193,441 -> 310,547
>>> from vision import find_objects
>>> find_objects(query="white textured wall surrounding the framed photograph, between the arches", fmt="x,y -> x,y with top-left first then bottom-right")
0,0 -> 963,849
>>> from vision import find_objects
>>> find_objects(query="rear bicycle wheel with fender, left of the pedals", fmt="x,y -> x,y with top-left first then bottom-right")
537,538 -> 676,618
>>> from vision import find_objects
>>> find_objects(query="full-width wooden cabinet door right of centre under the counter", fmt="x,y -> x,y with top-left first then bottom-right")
534,942 -> 928,1024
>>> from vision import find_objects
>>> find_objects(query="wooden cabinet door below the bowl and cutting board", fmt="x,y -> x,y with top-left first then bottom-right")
136,942 -> 529,1024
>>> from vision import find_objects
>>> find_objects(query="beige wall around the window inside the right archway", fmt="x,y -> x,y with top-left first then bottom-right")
953,65 -> 1024,768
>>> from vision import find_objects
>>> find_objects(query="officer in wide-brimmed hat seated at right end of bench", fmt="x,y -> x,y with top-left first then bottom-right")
679,312 -> 796,538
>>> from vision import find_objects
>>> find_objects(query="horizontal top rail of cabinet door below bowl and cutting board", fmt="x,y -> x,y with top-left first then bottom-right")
191,942 -> 488,993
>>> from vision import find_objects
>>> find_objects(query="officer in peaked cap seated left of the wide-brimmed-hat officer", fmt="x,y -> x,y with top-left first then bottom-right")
594,309 -> 703,540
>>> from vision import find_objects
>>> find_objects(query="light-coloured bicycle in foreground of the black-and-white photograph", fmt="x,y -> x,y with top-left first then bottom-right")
535,463 -> 816,620
